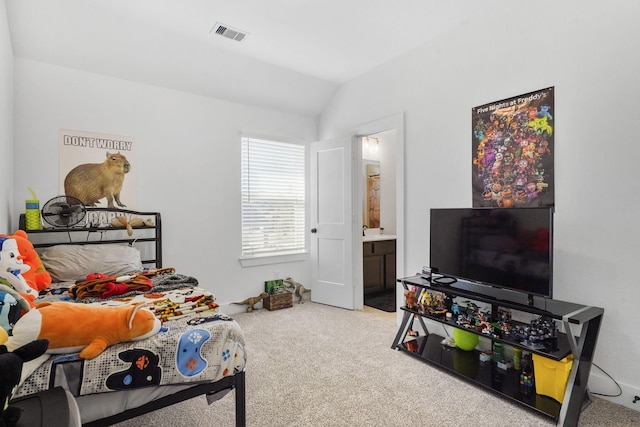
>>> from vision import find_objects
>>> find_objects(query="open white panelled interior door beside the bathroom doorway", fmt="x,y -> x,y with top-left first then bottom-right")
310,138 -> 355,310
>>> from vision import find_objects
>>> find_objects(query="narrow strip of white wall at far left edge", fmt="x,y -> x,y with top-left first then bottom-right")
0,0 -> 15,232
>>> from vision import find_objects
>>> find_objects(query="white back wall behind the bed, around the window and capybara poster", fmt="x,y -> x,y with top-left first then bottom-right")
13,58 -> 316,310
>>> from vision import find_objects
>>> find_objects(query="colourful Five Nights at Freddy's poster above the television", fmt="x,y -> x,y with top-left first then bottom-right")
472,87 -> 555,208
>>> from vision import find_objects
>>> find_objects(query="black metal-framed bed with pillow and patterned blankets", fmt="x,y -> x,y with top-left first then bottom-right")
13,208 -> 246,426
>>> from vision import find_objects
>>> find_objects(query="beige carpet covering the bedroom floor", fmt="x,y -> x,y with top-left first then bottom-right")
118,302 -> 640,427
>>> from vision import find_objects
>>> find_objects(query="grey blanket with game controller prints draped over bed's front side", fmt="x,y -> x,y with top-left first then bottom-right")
14,313 -> 246,397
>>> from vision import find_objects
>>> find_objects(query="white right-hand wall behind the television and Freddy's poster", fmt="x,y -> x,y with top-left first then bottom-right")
319,0 -> 640,409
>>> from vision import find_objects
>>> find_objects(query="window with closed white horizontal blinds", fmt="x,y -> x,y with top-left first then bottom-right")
242,137 -> 306,258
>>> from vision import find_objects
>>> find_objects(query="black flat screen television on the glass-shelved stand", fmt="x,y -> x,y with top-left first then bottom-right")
429,208 -> 553,298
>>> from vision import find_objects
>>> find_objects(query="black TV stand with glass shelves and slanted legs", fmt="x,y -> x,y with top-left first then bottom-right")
391,275 -> 604,426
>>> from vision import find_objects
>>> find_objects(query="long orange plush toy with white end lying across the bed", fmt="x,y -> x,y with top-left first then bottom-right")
5,302 -> 161,359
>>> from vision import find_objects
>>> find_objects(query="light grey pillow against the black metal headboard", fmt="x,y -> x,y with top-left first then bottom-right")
40,244 -> 142,282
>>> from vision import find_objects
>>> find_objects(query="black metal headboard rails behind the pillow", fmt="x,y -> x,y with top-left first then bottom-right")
19,207 -> 162,268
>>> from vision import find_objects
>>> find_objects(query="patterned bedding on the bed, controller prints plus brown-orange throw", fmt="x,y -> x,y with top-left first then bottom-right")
13,275 -> 246,398
